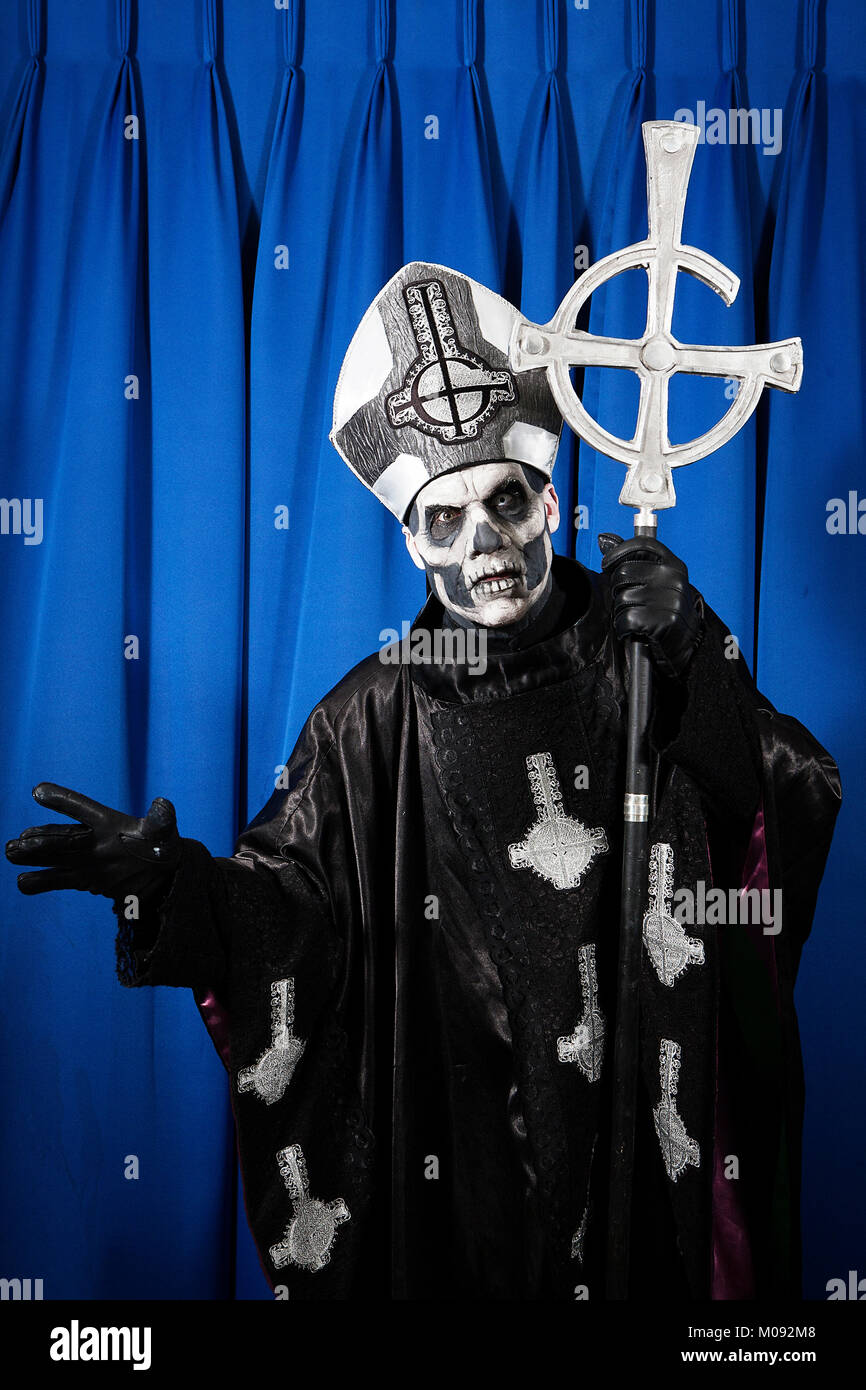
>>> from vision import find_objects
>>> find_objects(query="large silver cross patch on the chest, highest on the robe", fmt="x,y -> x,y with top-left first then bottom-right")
509,753 -> 607,888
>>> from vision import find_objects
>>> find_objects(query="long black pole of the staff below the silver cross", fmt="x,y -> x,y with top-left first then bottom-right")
606,510 -> 656,1300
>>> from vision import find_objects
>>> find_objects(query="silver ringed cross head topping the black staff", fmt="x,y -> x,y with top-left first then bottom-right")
509,121 -> 803,512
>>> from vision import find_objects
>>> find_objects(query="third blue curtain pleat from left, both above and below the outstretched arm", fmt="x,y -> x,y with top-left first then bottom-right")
139,0 -> 246,1297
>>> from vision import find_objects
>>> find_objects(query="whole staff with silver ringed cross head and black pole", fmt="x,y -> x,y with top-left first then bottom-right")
509,121 -> 803,1300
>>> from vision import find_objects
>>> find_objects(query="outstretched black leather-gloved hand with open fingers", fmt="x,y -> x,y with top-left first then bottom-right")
6,783 -> 181,898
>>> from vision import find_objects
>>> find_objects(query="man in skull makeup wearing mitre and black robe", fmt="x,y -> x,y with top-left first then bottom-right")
7,263 -> 840,1300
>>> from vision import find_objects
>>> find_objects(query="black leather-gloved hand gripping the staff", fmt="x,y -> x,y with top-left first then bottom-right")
598,532 -> 703,676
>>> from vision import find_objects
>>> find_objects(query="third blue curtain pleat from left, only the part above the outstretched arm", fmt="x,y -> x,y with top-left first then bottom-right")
147,0 -> 246,847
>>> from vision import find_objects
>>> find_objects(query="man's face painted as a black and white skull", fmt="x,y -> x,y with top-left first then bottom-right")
403,461 -> 559,627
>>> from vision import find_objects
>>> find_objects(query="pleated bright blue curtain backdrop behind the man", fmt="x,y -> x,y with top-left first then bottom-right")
0,0 -> 866,1298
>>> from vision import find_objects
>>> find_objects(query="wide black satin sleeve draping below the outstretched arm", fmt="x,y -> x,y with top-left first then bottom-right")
109,660 -> 392,1300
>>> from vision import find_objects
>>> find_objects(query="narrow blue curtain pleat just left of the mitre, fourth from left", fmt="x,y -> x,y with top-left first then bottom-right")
246,0 -> 308,816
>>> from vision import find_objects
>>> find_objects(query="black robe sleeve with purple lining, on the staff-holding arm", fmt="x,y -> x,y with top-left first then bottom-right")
651,589 -> 841,1298
